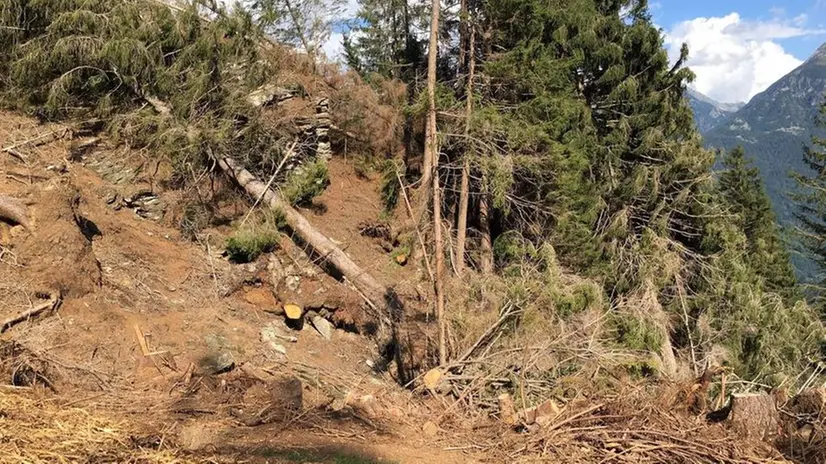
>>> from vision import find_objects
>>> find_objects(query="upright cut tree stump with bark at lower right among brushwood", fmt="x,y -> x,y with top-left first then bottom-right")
727,393 -> 780,440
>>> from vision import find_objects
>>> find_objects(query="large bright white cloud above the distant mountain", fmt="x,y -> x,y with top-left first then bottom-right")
665,11 -> 824,102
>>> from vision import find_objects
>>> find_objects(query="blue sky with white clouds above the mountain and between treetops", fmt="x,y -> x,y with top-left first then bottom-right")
324,0 -> 826,103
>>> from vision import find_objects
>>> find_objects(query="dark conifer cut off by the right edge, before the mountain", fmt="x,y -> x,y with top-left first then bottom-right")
792,99 -> 826,305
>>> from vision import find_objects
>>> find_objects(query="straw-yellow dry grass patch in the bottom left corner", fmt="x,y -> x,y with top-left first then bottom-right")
0,387 -> 195,464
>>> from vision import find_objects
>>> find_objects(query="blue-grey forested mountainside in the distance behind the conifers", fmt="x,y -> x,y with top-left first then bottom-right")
704,44 -> 826,277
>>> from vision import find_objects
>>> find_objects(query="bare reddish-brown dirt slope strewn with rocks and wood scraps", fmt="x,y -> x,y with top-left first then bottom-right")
0,113 -> 469,463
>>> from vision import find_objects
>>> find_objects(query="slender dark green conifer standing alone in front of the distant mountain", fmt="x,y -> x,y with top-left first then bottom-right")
719,147 -> 796,296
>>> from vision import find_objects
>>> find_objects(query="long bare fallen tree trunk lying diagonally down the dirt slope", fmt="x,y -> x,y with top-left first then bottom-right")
217,158 -> 401,332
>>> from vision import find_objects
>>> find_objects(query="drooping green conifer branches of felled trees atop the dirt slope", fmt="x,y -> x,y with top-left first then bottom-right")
0,0 -> 283,182
